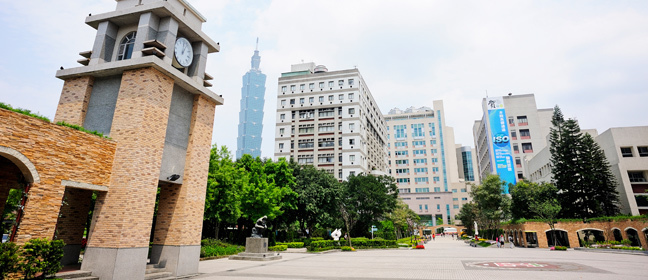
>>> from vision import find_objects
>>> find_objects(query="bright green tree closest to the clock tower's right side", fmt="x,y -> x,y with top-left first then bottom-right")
204,145 -> 248,239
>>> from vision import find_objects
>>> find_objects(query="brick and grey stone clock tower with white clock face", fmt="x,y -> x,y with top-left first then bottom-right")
55,0 -> 223,280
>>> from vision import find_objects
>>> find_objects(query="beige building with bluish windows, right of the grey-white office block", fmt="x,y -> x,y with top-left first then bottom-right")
385,101 -> 472,225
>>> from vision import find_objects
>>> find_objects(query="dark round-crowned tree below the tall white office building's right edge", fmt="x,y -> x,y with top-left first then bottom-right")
338,173 -> 398,246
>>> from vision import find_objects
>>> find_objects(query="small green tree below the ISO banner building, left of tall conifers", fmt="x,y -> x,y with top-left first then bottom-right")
509,180 -> 558,220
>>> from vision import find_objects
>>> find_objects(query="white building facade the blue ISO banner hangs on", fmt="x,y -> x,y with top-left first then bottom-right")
473,94 -> 553,186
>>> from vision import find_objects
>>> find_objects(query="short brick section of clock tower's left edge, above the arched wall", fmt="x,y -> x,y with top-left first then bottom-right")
54,76 -> 94,125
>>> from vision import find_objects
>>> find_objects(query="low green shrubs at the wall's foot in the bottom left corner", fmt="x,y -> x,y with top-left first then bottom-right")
0,238 -> 65,279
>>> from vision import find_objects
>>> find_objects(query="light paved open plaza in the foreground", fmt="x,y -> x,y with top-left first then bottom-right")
191,237 -> 648,280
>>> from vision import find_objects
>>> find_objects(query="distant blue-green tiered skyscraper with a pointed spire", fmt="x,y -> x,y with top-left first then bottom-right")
236,39 -> 266,159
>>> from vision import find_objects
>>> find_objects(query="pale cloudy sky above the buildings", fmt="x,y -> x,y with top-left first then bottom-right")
0,0 -> 648,160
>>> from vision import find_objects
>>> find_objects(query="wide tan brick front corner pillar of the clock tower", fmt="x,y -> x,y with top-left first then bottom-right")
88,68 -> 174,248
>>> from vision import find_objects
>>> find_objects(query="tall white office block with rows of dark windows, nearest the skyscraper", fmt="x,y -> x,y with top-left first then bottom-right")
274,62 -> 387,180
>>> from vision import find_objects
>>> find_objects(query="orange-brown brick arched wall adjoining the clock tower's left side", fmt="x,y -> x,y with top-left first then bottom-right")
0,109 -> 116,243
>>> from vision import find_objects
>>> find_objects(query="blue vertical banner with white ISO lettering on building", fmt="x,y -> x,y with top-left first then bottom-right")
486,96 -> 516,193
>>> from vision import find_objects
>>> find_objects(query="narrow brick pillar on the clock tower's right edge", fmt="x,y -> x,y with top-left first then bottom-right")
153,95 -> 216,245
